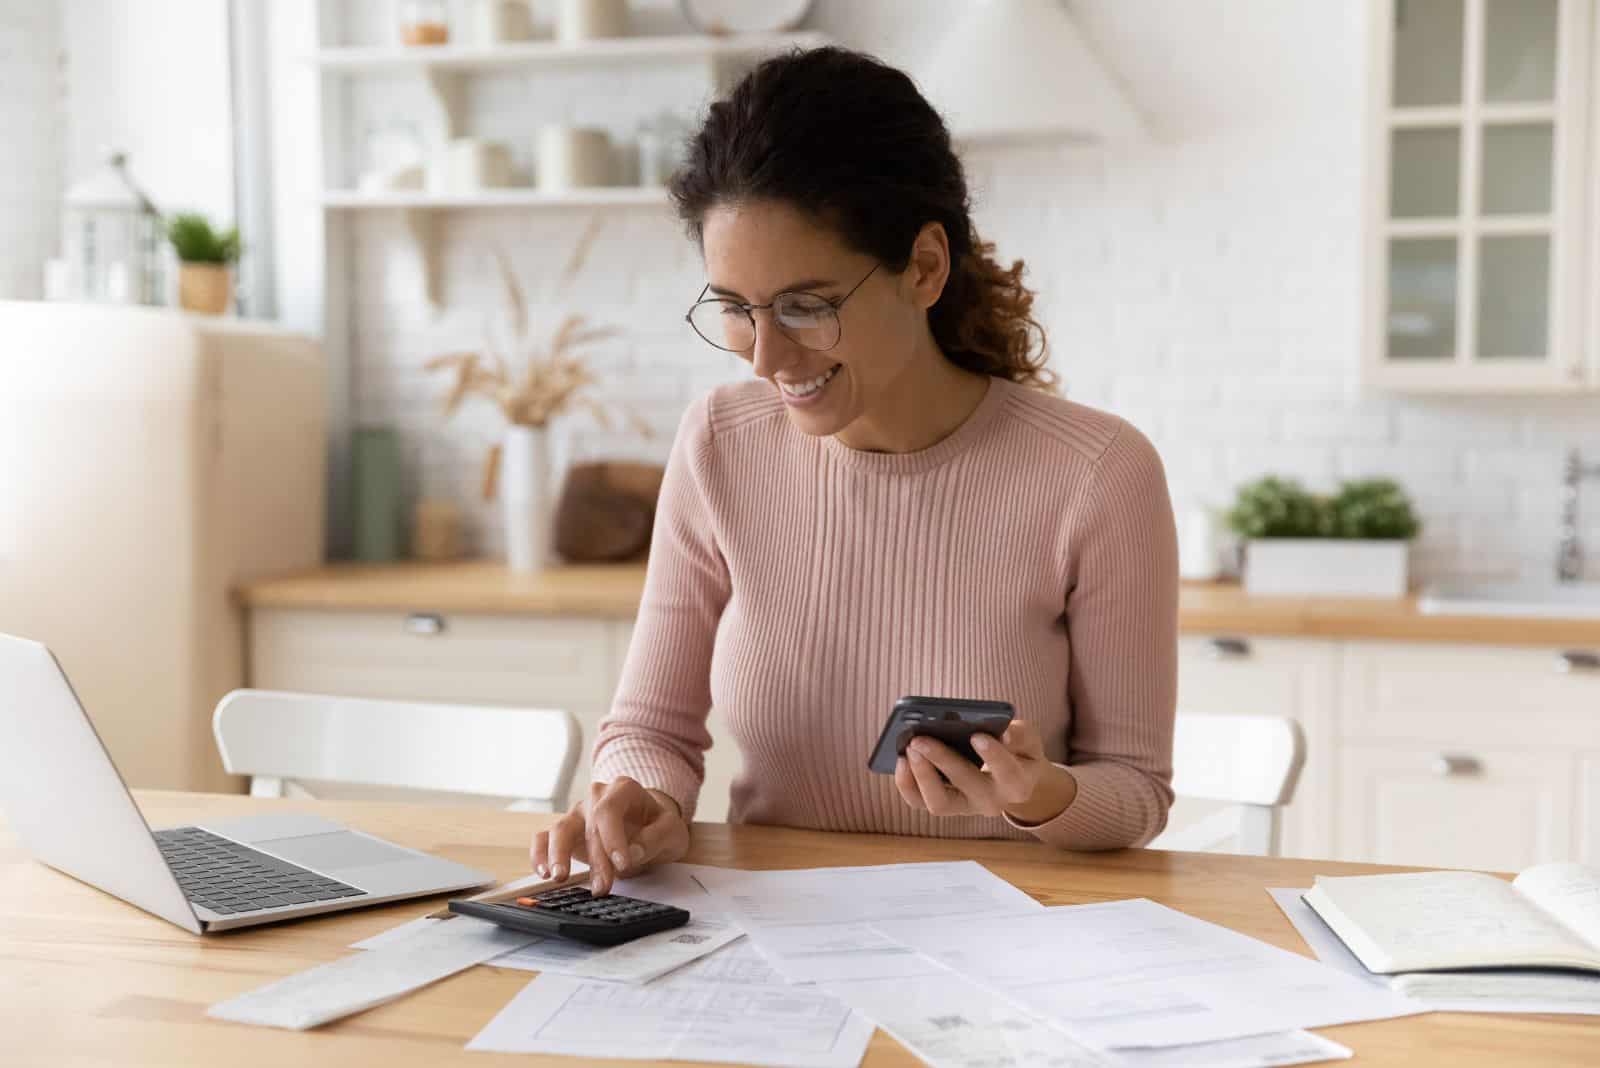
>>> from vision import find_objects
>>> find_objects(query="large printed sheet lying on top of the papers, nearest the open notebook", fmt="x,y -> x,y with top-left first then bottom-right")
878,899 -> 1422,1049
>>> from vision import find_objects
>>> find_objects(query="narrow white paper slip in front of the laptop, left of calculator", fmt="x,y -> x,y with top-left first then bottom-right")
206,916 -> 531,1031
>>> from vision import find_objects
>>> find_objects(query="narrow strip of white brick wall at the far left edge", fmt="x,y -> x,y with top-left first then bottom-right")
0,0 -> 62,299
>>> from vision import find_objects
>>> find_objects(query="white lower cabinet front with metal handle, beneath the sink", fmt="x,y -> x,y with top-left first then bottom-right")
1334,641 -> 1600,870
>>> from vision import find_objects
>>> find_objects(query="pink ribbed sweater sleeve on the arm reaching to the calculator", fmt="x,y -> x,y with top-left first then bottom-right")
594,398 -> 730,819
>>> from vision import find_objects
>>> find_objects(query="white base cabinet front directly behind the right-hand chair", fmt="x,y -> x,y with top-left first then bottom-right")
1168,635 -> 1339,857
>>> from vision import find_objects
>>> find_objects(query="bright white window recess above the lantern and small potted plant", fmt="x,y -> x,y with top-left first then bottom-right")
61,0 -> 234,222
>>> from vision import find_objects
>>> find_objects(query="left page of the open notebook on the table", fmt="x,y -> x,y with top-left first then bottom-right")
1317,871 -> 1594,972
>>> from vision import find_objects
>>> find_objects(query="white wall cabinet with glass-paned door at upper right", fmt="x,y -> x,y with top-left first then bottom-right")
1363,0 -> 1600,392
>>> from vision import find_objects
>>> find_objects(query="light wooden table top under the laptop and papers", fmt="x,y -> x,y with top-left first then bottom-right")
0,791 -> 1600,1068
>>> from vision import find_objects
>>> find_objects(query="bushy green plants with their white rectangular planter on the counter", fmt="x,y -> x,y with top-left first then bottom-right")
1227,476 -> 1422,596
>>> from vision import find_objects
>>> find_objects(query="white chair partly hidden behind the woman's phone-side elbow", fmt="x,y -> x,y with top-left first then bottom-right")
1150,716 -> 1306,857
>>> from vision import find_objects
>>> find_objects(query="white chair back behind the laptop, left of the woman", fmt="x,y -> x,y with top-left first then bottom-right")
211,689 -> 581,812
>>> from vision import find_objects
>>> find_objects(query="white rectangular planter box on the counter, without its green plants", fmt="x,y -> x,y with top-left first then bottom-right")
1245,537 -> 1411,596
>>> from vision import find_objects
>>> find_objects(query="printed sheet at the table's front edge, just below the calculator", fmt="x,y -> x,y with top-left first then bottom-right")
467,940 -> 872,1068
